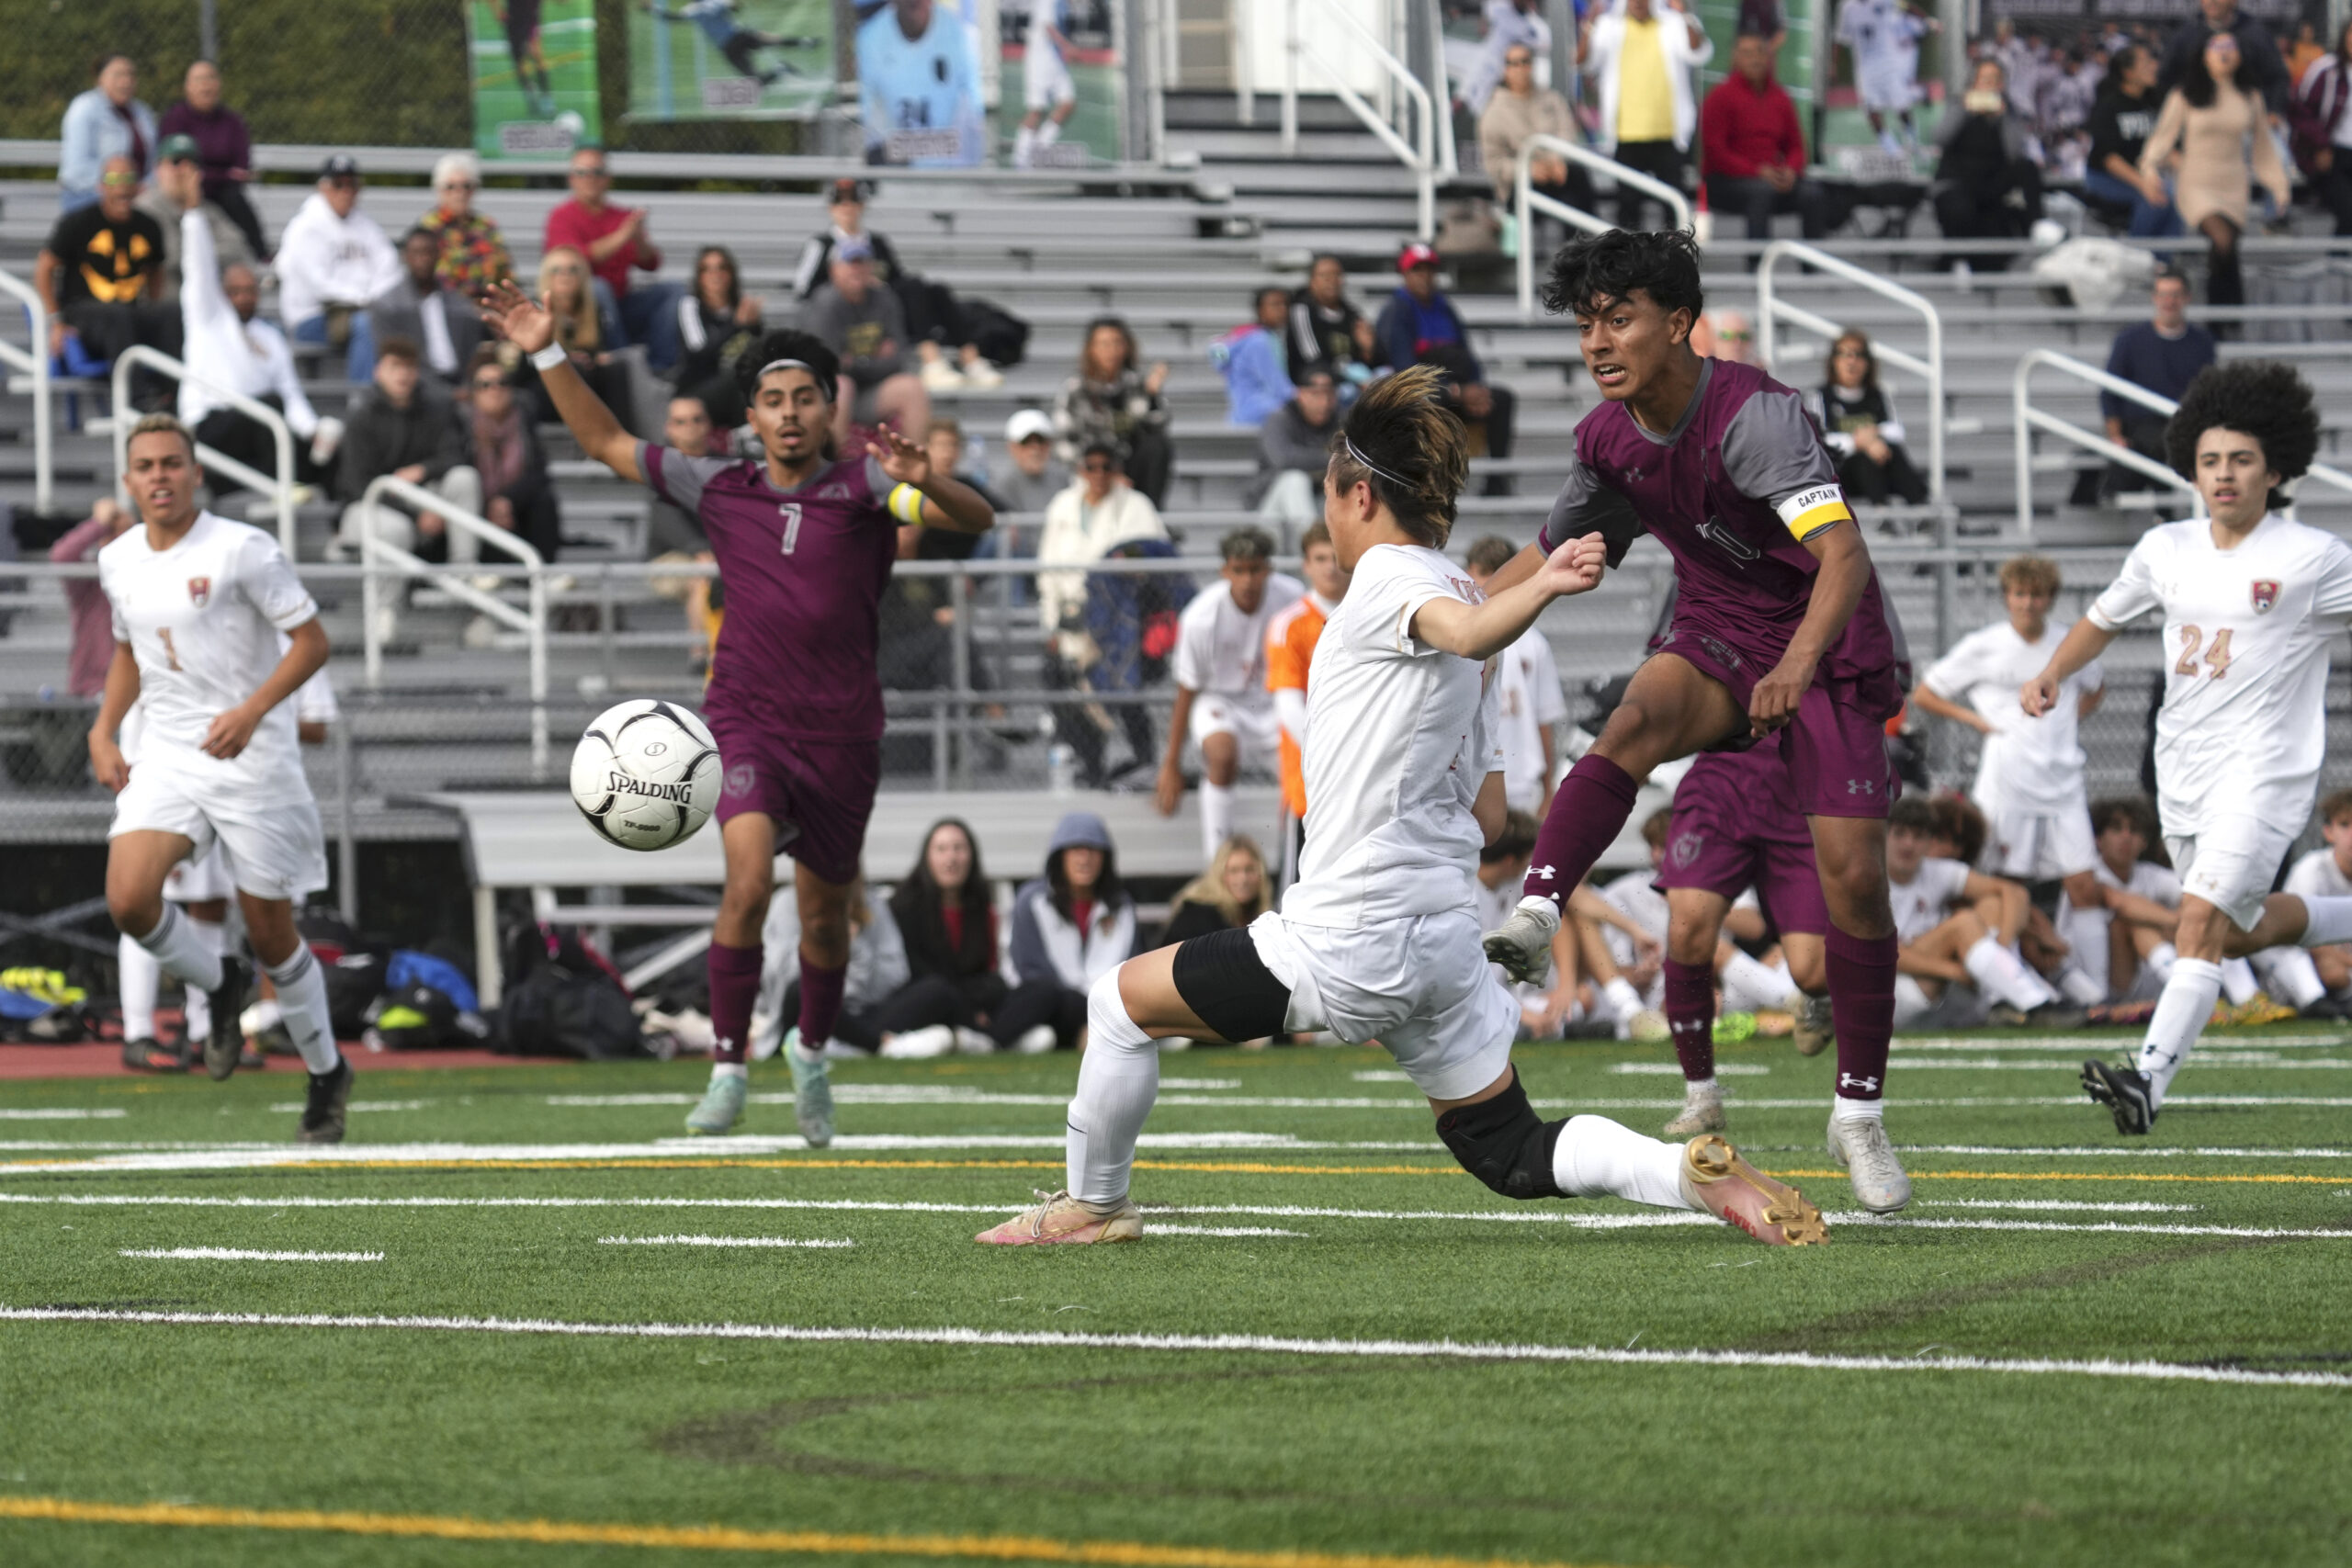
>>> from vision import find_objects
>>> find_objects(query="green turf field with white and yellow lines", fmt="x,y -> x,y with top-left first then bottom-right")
0,1025 -> 2352,1568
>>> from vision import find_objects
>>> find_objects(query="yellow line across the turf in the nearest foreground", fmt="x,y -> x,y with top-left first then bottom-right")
0,1497 -> 1627,1568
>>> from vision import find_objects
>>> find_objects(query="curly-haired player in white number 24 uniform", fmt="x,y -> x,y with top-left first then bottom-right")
2020,362 -> 2352,1134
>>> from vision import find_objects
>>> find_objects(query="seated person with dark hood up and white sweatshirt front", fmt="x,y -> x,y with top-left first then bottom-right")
990,811 -> 1138,1054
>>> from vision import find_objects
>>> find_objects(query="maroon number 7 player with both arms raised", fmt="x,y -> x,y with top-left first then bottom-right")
482,282 -> 997,1147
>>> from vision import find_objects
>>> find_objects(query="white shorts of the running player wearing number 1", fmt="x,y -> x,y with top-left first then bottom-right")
106,745 -> 327,900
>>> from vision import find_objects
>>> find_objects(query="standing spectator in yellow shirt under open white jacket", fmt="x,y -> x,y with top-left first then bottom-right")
1576,0 -> 1714,228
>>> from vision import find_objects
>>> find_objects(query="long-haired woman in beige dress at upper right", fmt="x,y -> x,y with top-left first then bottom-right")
2141,32 -> 2290,306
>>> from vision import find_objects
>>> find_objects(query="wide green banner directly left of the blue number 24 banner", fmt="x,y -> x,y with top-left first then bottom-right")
628,0 -> 835,120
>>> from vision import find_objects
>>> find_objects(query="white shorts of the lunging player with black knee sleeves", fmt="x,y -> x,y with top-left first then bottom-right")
1249,905 -> 1520,1100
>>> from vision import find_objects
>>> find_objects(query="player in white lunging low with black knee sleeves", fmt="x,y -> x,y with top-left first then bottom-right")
981,367 -> 1827,1246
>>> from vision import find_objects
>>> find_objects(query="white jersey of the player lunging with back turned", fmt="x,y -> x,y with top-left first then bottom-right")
1282,546 -> 1503,929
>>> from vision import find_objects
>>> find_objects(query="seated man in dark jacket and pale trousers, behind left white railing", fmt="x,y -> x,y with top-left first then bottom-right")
334,339 -> 482,562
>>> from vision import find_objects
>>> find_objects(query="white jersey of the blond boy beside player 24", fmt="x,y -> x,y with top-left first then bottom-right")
1919,621 -> 2108,816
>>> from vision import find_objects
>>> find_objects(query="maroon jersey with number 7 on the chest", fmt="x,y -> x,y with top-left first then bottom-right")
638,442 -> 899,740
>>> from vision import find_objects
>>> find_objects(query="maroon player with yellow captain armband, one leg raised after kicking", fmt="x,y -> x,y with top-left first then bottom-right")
1487,231 -> 1910,1213
